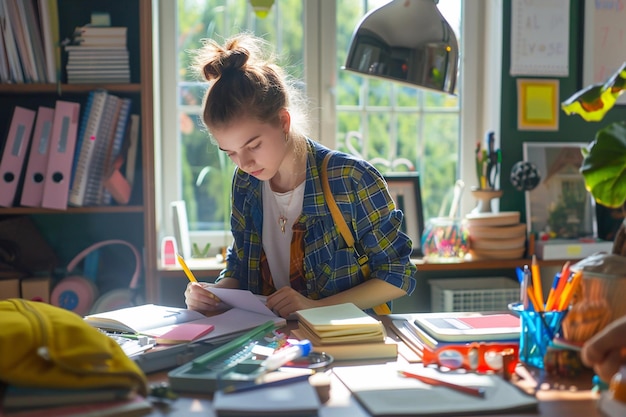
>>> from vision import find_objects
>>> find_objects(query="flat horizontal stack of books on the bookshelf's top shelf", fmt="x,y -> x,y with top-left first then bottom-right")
65,25 -> 130,84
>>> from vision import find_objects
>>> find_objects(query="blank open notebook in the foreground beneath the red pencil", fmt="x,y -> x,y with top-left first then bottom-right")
333,363 -> 538,417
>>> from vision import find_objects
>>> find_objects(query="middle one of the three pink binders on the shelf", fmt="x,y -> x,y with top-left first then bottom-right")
20,106 -> 54,207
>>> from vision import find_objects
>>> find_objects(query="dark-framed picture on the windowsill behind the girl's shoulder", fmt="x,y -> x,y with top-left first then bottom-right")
384,172 -> 424,256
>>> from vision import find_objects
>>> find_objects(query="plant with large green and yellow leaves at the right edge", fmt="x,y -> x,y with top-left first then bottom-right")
561,62 -> 626,256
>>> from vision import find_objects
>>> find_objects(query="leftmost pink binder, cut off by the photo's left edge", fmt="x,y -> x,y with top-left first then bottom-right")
0,106 -> 35,207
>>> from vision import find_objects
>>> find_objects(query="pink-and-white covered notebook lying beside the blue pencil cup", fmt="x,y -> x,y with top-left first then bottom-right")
411,312 -> 520,342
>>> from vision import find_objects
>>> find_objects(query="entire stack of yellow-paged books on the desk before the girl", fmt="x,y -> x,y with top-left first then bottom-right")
291,303 -> 398,360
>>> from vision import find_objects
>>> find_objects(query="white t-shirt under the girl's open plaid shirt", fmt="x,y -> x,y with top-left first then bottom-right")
262,181 -> 306,289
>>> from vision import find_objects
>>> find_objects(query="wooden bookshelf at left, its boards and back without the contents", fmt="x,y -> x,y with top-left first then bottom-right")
0,0 -> 158,302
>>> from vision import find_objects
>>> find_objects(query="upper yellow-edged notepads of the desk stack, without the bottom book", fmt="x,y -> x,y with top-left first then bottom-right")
296,303 -> 386,345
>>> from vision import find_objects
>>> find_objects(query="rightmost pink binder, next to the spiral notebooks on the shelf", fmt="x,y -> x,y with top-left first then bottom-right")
41,100 -> 80,210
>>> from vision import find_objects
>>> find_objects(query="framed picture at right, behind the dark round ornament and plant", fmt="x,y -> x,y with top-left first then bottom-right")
523,142 -> 598,239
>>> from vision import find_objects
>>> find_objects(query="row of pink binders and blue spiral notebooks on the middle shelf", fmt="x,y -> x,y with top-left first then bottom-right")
0,90 -> 139,210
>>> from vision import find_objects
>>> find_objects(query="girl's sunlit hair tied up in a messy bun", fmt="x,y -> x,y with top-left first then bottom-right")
193,33 -> 307,153
